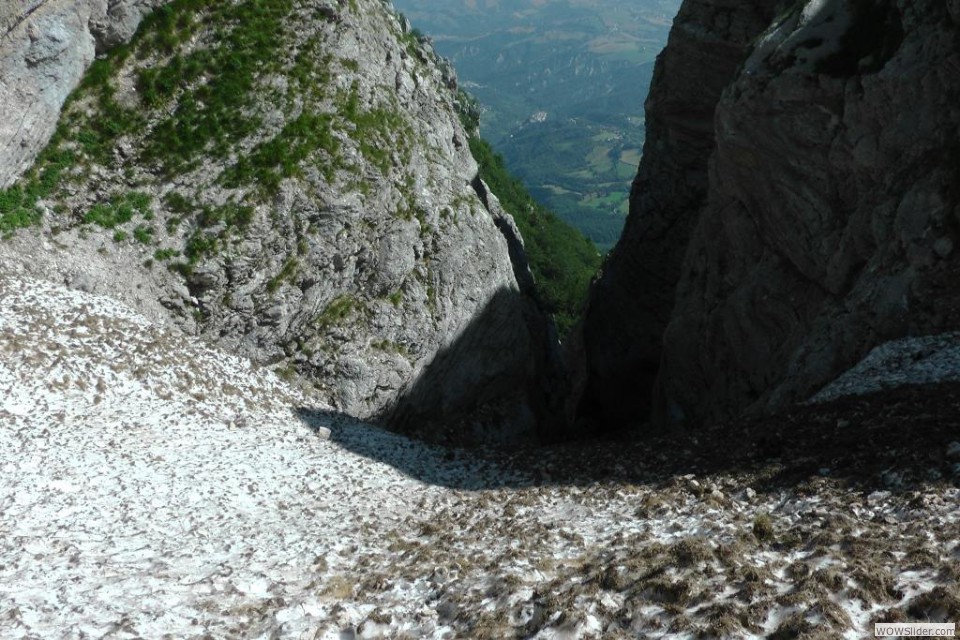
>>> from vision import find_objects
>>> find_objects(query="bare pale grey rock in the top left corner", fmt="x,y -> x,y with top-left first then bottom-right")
0,0 -> 169,188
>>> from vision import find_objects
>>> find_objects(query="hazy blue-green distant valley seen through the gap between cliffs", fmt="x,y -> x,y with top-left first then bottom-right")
395,0 -> 680,251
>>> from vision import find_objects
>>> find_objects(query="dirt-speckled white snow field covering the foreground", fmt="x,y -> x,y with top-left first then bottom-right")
0,276 -> 960,639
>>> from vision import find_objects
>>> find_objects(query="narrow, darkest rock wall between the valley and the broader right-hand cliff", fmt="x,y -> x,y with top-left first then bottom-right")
577,0 -> 772,429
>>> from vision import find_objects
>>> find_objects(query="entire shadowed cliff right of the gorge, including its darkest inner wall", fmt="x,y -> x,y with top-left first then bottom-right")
581,0 -> 960,430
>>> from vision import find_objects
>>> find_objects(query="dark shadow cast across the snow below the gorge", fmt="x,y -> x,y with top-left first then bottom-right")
301,383 -> 960,494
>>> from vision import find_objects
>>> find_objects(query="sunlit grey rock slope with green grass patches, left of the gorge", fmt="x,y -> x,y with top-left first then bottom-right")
0,0 -> 555,437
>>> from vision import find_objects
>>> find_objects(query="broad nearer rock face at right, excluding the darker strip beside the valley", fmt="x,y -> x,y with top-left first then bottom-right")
657,0 -> 960,421
